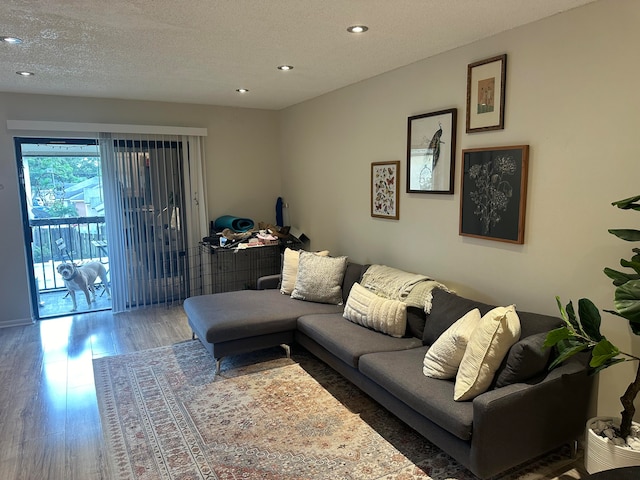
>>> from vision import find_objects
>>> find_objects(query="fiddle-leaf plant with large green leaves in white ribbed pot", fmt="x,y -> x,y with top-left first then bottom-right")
545,195 -> 640,473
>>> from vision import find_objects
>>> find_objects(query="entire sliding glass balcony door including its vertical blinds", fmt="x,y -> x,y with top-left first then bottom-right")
15,133 -> 208,319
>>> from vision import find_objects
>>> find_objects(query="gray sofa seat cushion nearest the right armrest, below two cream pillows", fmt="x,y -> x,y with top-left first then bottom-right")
359,347 -> 473,441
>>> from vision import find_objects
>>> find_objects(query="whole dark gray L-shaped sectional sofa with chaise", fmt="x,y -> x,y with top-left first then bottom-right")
184,263 -> 592,479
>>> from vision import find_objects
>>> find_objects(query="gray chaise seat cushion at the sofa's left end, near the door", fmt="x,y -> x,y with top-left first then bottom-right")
183,290 -> 342,343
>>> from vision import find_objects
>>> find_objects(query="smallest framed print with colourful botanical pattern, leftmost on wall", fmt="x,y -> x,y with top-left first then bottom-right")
371,160 -> 400,220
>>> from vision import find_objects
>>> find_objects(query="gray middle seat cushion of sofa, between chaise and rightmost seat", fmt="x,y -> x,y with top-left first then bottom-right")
298,314 -> 422,368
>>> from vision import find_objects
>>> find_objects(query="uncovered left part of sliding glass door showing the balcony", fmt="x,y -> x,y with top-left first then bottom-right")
15,138 -> 111,319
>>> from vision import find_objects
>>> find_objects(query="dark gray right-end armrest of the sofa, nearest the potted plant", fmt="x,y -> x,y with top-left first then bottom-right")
471,356 -> 593,474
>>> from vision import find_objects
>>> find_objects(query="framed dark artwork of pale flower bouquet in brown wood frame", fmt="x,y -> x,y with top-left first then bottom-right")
460,145 -> 529,244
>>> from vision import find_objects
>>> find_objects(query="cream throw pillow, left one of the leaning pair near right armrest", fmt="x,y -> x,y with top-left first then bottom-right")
422,308 -> 481,379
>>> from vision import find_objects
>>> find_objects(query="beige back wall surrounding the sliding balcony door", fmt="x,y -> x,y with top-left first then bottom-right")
0,93 -> 282,324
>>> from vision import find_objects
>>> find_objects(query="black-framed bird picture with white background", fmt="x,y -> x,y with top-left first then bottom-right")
407,108 -> 458,194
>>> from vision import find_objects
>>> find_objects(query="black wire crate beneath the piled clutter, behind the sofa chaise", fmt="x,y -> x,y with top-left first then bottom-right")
200,243 -> 281,294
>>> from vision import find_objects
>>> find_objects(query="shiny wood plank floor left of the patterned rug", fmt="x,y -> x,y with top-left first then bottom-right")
0,306 -> 191,480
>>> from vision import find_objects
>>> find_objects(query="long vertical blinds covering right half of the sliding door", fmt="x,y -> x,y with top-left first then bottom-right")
100,133 -> 208,312
